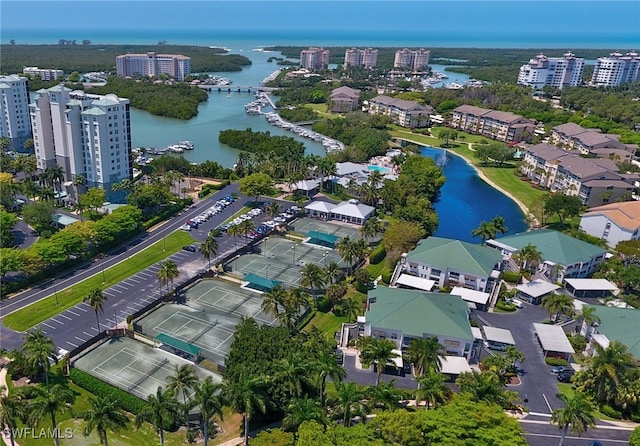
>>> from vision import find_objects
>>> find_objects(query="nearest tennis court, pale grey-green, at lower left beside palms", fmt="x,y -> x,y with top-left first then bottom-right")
74,336 -> 222,400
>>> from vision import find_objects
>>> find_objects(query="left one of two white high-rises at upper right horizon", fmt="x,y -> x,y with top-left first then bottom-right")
518,52 -> 584,89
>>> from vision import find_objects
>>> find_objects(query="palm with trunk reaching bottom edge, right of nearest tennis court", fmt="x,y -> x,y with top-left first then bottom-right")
222,374 -> 267,446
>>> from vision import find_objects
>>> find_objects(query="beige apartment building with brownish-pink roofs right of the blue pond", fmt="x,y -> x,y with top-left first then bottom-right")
521,143 -> 637,207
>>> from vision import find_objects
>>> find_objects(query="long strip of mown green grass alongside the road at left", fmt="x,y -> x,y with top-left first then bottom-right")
3,231 -> 193,331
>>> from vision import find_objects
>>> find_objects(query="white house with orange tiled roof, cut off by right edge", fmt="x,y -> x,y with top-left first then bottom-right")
580,201 -> 640,248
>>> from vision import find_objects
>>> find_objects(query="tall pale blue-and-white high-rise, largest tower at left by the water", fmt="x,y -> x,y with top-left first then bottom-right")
29,85 -> 133,201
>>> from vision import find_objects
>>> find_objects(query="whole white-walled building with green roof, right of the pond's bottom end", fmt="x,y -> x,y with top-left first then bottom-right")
487,229 -> 607,282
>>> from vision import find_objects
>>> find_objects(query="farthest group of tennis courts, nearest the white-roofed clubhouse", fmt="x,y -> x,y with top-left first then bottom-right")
227,237 -> 347,288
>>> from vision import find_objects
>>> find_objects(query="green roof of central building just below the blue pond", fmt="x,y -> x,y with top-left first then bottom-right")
407,237 -> 502,277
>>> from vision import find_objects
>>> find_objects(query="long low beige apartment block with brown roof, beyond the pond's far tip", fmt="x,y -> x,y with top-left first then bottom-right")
451,105 -> 536,143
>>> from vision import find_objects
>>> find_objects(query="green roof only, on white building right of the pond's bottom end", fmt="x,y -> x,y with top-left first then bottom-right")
497,229 -> 607,265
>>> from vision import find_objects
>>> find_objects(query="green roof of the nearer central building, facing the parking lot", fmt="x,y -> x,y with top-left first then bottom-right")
365,286 -> 474,340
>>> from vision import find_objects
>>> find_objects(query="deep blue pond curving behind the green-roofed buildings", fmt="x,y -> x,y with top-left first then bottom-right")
422,146 -> 527,243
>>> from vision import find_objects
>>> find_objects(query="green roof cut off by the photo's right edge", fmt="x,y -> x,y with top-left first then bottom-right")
595,305 -> 640,360
